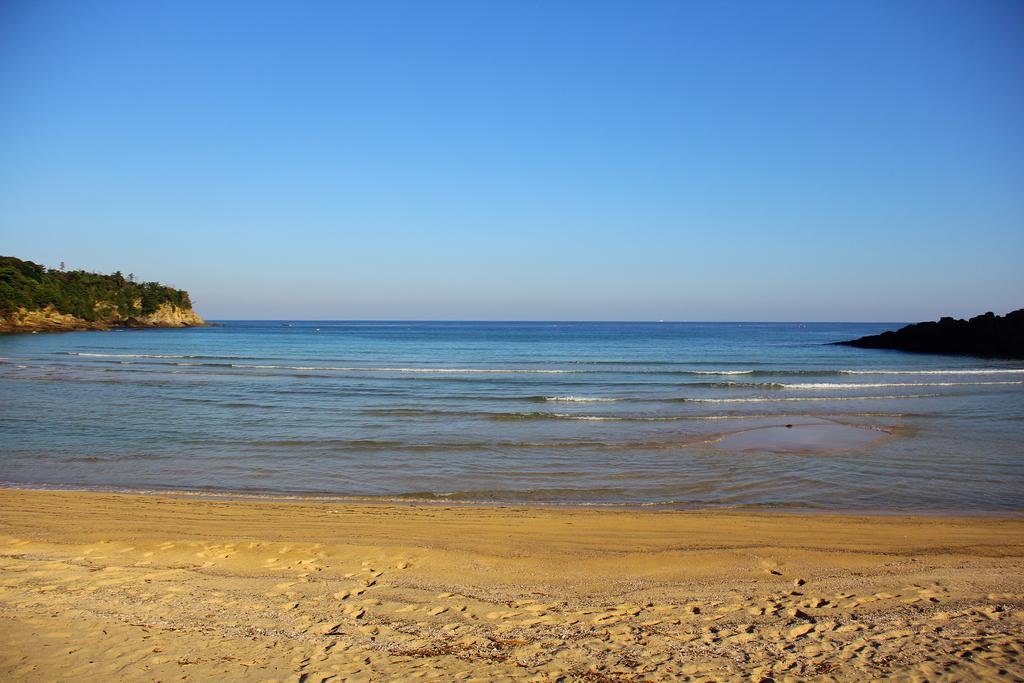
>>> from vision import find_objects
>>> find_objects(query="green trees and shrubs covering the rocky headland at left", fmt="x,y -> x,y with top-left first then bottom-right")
0,256 -> 191,322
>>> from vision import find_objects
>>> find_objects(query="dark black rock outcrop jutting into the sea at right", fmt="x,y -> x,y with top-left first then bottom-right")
836,308 -> 1024,358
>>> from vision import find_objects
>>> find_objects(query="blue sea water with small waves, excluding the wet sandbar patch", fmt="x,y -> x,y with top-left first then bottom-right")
0,322 -> 1024,511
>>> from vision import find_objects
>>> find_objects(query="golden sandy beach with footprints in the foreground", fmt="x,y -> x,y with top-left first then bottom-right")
0,489 -> 1024,682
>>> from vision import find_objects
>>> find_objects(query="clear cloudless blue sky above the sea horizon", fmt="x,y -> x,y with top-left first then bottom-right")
0,0 -> 1024,321
